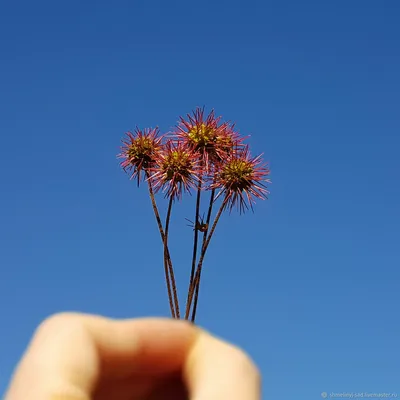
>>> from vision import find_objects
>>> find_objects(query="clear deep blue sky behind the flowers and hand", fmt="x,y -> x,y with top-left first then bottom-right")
0,0 -> 400,400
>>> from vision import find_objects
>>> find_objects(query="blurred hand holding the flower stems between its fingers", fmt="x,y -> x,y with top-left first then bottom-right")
5,313 -> 260,400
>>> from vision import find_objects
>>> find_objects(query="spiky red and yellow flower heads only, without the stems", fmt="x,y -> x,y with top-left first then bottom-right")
119,108 -> 269,212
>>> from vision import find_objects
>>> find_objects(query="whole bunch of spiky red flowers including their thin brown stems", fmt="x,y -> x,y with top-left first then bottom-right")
118,108 -> 269,322
